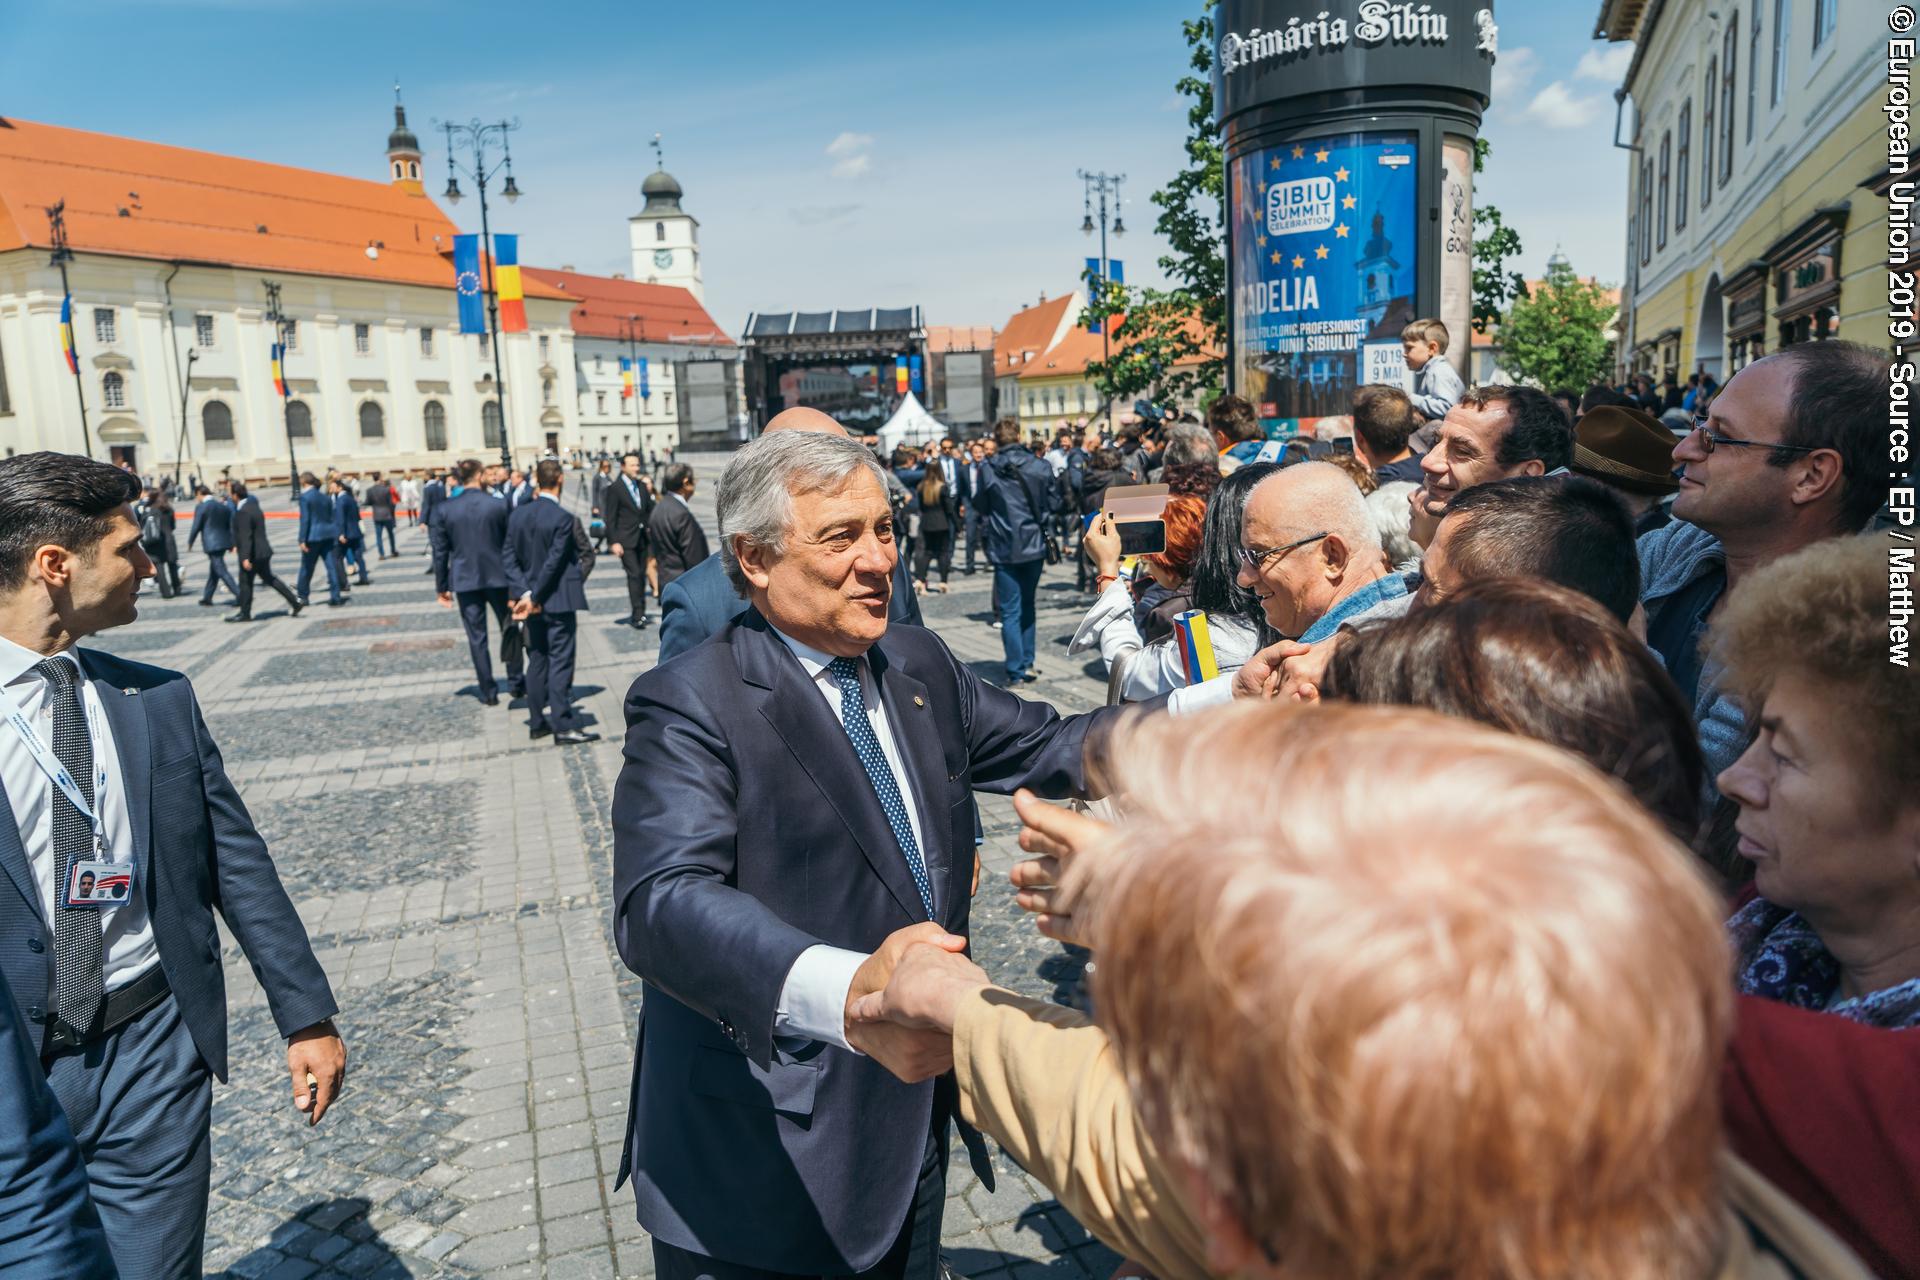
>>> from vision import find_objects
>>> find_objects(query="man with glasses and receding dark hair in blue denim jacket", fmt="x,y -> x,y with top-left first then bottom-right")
1640,342 -> 1889,794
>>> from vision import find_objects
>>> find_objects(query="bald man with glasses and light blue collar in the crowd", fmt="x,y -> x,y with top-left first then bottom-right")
1169,462 -> 1415,712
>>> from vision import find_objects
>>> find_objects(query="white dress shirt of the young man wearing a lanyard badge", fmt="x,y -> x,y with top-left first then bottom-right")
0,635 -> 159,990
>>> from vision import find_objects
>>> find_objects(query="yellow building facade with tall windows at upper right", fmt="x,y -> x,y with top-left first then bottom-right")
1597,0 -> 1889,382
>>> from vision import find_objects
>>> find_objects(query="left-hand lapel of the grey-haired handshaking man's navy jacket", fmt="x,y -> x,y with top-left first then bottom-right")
733,608 -> 927,919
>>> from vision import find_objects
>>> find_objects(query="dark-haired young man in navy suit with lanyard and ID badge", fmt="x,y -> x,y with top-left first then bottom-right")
0,453 -> 346,1276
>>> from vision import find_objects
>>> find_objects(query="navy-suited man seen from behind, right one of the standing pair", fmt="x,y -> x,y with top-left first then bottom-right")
503,459 -> 599,747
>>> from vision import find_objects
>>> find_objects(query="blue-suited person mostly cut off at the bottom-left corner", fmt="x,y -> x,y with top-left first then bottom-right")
0,973 -> 115,1280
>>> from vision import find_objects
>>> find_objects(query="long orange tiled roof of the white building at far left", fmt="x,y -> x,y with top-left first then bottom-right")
0,117 -> 563,297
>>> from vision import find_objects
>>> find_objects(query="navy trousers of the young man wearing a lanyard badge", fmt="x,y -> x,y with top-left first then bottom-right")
46,996 -> 214,1280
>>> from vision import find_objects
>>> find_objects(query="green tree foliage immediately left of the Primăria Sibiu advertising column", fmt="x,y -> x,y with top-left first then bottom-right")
1087,4 -> 1227,399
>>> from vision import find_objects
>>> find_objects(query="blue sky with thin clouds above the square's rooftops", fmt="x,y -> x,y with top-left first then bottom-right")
0,0 -> 1626,332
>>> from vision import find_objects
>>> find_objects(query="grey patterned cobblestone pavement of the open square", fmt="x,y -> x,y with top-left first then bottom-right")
100,459 -> 1119,1280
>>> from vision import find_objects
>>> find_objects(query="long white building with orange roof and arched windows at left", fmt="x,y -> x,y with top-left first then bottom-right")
0,107 -> 586,480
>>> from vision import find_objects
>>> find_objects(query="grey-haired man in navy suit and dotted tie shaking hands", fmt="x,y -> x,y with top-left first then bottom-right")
612,432 -> 1127,1280
